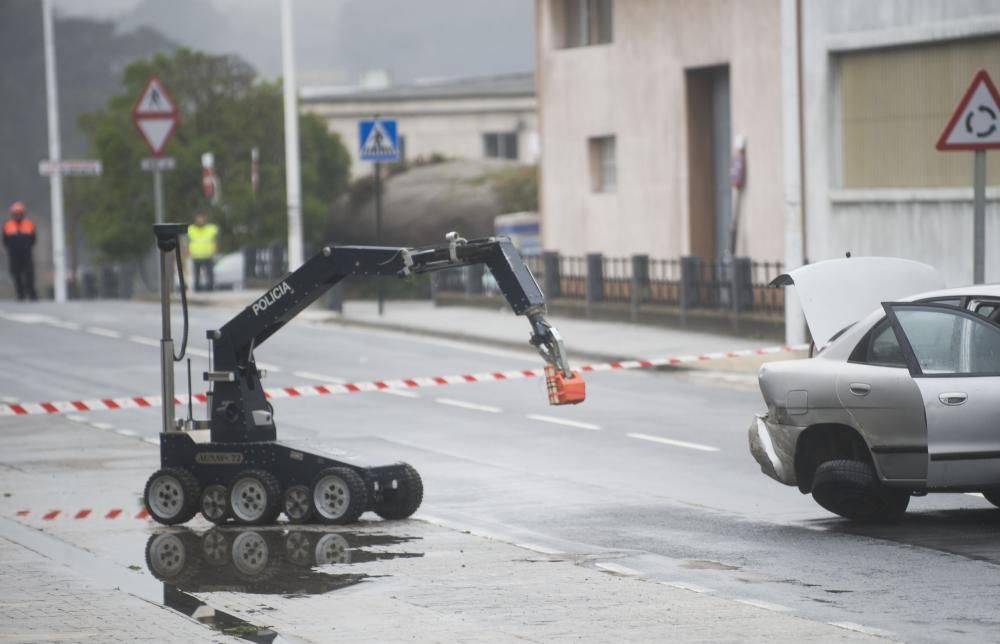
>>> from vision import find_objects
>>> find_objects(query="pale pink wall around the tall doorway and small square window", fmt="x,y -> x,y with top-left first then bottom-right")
536,0 -> 784,260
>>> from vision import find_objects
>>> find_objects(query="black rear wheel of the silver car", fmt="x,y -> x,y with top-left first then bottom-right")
812,460 -> 910,522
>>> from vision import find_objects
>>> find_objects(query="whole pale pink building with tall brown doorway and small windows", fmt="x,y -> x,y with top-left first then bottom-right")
536,0 -> 784,260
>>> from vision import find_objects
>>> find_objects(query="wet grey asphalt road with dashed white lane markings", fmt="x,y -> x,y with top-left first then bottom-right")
0,302 -> 1000,641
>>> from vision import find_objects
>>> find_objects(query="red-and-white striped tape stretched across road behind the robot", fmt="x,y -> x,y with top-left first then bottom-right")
0,344 -> 809,417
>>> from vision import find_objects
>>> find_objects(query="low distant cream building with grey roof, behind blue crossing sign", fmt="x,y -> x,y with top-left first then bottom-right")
301,74 -> 539,177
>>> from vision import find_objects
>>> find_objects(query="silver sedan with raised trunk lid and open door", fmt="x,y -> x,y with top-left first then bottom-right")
750,257 -> 1000,521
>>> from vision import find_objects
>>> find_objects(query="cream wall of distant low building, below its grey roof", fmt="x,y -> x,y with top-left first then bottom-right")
304,97 -> 539,178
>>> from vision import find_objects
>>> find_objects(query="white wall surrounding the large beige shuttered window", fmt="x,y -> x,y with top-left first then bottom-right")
802,0 -> 1000,286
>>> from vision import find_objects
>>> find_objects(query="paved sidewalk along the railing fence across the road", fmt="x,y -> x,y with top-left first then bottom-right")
190,291 -> 805,373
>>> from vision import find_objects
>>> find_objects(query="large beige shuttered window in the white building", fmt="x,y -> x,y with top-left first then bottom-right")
834,37 -> 1000,189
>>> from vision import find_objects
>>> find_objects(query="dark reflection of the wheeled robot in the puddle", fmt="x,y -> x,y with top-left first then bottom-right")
146,527 -> 423,644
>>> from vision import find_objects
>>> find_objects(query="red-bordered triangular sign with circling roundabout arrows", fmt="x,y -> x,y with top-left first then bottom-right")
937,69 -> 1000,150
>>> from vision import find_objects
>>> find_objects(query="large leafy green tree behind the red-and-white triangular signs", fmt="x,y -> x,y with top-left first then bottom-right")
78,49 -> 350,259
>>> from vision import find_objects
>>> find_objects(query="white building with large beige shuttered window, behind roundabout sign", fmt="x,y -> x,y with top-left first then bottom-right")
801,0 -> 1000,286
